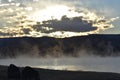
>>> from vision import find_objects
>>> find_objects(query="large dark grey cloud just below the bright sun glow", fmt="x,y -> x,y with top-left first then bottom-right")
34,16 -> 97,32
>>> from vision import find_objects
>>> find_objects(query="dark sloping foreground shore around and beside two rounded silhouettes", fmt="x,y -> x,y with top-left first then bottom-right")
0,66 -> 120,80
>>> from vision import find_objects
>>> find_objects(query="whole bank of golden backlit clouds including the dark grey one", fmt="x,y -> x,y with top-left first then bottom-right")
0,0 -> 119,38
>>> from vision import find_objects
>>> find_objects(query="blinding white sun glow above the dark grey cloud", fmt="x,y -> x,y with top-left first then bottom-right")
29,5 -> 80,22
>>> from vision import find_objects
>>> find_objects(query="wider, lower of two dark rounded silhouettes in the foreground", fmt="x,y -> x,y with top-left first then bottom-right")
22,66 -> 40,80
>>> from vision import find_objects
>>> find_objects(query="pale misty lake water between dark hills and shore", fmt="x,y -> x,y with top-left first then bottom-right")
0,56 -> 120,73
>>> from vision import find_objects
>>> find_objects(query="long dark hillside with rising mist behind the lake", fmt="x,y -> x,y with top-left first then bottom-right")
0,35 -> 120,58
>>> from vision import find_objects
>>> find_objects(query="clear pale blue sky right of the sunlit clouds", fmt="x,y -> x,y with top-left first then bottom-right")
80,0 -> 120,34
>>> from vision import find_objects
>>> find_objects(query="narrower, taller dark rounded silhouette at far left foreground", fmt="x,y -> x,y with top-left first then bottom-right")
7,64 -> 21,80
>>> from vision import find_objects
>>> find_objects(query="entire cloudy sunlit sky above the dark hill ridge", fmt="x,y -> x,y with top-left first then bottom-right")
0,0 -> 120,38
